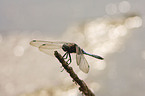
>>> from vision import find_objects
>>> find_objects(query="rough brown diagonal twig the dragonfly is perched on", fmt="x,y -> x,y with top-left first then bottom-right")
54,51 -> 95,96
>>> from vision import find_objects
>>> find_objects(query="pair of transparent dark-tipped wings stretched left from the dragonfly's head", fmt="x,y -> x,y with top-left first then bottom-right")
30,40 -> 66,55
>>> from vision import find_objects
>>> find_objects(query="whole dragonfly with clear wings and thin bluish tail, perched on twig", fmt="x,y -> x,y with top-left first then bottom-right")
30,40 -> 104,73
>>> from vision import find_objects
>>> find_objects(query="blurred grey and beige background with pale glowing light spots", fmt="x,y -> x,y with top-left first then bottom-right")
0,0 -> 145,96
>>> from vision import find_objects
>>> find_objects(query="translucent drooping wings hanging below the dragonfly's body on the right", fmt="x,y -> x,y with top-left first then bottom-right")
76,47 -> 89,73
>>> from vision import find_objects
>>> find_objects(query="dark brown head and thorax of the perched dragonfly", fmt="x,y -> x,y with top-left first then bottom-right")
62,43 -> 77,53
